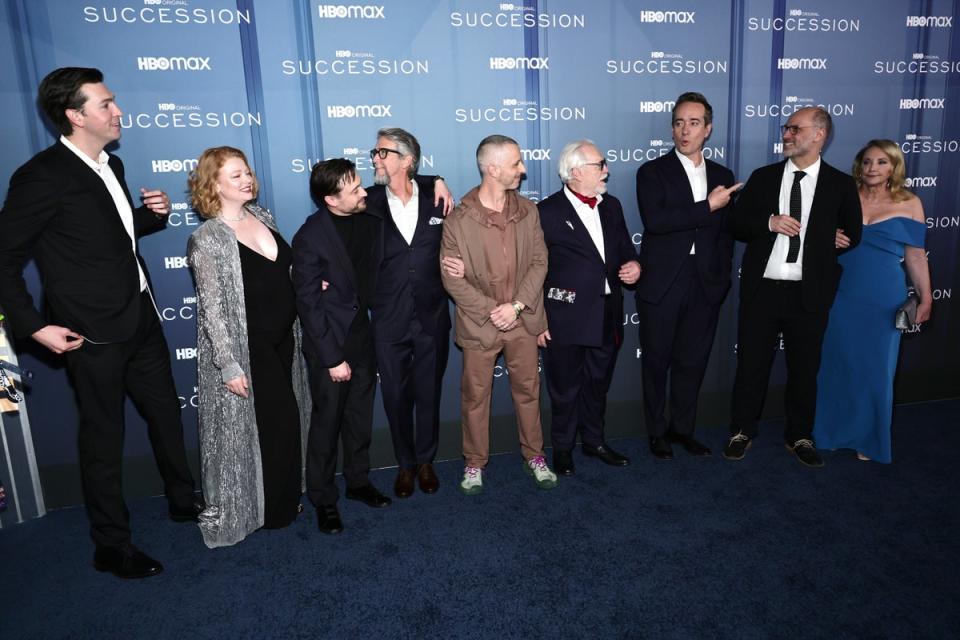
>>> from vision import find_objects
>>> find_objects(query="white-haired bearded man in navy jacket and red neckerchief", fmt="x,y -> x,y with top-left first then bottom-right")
537,140 -> 640,476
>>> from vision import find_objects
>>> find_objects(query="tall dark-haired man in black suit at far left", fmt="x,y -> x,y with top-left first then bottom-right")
0,67 -> 202,578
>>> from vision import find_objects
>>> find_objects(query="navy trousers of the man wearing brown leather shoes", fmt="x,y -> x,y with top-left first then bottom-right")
376,318 -> 450,469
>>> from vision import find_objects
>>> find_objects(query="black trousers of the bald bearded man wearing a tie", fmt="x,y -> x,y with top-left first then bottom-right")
730,278 -> 830,444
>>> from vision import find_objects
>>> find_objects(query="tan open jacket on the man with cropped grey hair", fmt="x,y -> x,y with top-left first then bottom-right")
440,188 -> 547,349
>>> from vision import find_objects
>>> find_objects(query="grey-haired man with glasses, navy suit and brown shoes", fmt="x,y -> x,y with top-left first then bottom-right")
367,128 -> 450,498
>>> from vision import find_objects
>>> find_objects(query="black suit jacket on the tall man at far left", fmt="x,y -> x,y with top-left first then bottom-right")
0,142 -> 166,342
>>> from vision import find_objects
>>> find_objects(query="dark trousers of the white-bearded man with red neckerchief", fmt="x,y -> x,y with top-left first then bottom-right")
542,296 -> 621,451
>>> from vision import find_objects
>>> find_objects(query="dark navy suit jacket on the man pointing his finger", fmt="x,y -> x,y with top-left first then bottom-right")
637,151 -> 734,304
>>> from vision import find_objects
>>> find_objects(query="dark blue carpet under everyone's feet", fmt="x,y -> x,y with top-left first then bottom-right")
0,400 -> 960,640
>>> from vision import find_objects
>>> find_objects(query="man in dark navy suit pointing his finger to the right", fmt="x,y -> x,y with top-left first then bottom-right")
637,92 -> 742,460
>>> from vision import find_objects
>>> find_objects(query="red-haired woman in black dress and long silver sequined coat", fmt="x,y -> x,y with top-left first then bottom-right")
187,147 -> 310,547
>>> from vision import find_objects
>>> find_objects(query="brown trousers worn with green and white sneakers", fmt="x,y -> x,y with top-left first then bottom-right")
460,326 -> 543,469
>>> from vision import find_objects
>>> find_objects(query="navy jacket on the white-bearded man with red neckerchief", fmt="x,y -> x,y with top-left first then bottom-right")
537,189 -> 637,347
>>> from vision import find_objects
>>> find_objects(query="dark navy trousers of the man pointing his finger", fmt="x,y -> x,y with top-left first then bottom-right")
637,256 -> 720,437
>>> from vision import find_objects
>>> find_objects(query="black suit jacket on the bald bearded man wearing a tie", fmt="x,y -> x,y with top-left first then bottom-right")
733,159 -> 863,311
